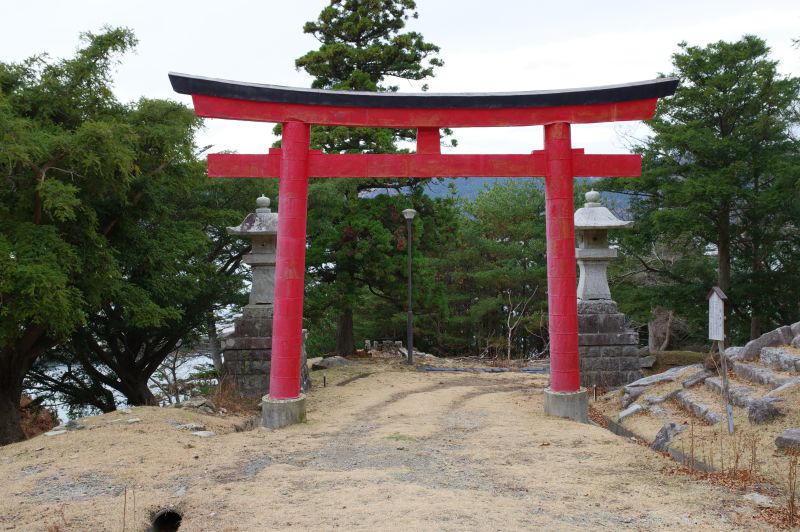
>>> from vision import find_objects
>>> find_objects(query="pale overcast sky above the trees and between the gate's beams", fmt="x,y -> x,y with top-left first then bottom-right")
0,0 -> 800,157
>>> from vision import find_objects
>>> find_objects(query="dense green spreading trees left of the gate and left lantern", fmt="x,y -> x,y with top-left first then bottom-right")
0,28 -> 274,426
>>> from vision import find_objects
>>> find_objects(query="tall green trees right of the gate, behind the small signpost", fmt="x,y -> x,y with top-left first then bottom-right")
606,36 -> 800,342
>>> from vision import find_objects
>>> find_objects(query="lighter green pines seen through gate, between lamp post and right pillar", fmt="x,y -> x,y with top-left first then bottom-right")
423,179 -> 547,356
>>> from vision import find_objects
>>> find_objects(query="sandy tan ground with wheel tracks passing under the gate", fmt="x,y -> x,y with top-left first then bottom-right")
0,363 -> 776,531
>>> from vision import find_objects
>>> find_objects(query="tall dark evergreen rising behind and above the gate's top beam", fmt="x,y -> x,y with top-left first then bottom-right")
290,0 -> 450,354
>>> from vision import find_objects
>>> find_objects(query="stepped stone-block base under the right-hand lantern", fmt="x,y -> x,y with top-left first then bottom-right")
578,299 -> 643,388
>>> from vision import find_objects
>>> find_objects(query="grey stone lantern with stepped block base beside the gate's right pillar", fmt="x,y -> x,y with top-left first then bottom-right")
575,190 -> 642,387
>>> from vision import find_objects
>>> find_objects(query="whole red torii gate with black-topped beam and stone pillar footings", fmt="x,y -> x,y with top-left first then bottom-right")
169,73 -> 678,427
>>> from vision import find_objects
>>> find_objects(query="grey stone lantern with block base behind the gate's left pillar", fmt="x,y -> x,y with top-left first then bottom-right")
222,196 -> 278,397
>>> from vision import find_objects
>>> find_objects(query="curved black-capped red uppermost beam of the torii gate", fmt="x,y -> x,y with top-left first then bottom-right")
169,73 -> 678,128
